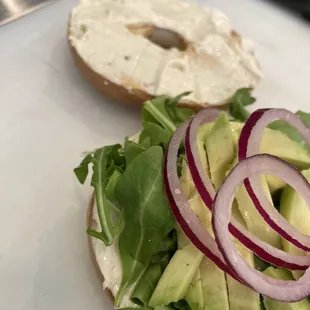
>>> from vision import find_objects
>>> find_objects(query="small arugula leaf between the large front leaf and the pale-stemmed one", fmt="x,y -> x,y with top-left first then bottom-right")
139,123 -> 172,149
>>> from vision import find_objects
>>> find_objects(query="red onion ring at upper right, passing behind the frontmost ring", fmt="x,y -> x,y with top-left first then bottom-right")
238,109 -> 310,251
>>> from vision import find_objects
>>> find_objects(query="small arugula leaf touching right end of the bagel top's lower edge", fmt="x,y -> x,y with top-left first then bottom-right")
229,88 -> 256,122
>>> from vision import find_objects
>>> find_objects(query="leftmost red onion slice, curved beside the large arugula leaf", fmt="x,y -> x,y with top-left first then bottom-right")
164,121 -> 236,278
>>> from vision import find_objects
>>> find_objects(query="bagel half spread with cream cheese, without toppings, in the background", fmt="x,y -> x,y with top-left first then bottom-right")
68,0 -> 261,110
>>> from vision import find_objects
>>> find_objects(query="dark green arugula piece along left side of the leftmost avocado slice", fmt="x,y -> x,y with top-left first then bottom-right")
131,264 -> 163,306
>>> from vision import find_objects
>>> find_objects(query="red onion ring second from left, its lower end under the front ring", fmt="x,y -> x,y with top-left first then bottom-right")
185,108 -> 310,270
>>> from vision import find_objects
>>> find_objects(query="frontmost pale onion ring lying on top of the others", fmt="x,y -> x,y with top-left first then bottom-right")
212,154 -> 310,302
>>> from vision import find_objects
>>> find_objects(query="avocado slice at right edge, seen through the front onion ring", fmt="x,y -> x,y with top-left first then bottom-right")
280,169 -> 310,279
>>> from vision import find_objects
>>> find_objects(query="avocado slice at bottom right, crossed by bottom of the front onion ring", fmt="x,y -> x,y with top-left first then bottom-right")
264,267 -> 310,310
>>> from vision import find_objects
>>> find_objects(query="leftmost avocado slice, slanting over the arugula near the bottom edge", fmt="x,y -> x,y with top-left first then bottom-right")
149,244 -> 203,307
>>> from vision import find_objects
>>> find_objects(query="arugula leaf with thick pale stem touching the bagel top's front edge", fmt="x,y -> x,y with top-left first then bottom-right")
142,93 -> 193,133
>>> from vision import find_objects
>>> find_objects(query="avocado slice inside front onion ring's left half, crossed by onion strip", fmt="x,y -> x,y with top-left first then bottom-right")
235,175 -> 282,249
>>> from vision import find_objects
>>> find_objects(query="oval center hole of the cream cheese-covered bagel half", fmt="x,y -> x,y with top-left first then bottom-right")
127,24 -> 187,51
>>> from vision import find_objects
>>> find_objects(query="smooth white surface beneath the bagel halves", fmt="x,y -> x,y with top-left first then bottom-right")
0,0 -> 310,310
